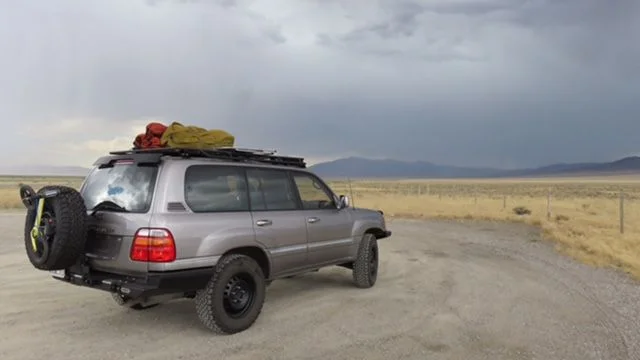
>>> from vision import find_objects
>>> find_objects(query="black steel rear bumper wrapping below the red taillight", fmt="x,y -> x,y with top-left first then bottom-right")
52,266 -> 213,299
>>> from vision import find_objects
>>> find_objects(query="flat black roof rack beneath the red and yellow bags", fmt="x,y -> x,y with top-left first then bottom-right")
109,147 -> 307,168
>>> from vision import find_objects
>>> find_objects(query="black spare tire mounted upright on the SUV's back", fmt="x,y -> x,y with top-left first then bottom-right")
24,186 -> 88,270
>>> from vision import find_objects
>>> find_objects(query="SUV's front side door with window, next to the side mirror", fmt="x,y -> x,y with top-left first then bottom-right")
291,171 -> 354,265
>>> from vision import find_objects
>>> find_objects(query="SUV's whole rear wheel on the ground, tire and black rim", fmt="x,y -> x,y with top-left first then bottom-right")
195,254 -> 266,334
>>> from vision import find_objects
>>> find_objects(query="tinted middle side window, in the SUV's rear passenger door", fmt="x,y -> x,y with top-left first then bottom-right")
247,169 -> 298,211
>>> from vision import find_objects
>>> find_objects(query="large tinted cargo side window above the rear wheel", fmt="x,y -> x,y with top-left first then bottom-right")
185,165 -> 249,212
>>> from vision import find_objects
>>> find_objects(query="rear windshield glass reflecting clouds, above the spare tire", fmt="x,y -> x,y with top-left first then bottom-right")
82,164 -> 158,213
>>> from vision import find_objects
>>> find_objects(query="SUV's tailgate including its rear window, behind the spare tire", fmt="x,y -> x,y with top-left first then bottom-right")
80,160 -> 158,275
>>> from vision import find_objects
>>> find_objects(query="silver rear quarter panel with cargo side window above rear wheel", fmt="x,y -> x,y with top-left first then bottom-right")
154,160 -> 255,271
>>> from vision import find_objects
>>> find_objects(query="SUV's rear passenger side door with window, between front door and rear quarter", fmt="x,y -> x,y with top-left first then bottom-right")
247,168 -> 308,276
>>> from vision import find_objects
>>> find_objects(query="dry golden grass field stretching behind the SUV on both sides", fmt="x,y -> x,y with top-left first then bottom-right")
0,176 -> 640,279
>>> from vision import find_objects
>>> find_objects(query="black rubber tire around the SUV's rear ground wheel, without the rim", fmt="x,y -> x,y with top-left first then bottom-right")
194,254 -> 266,335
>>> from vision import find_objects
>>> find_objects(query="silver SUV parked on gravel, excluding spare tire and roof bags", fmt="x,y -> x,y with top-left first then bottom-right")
42,148 -> 391,334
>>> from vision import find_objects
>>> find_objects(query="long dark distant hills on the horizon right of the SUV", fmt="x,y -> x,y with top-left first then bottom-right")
310,156 -> 640,178
